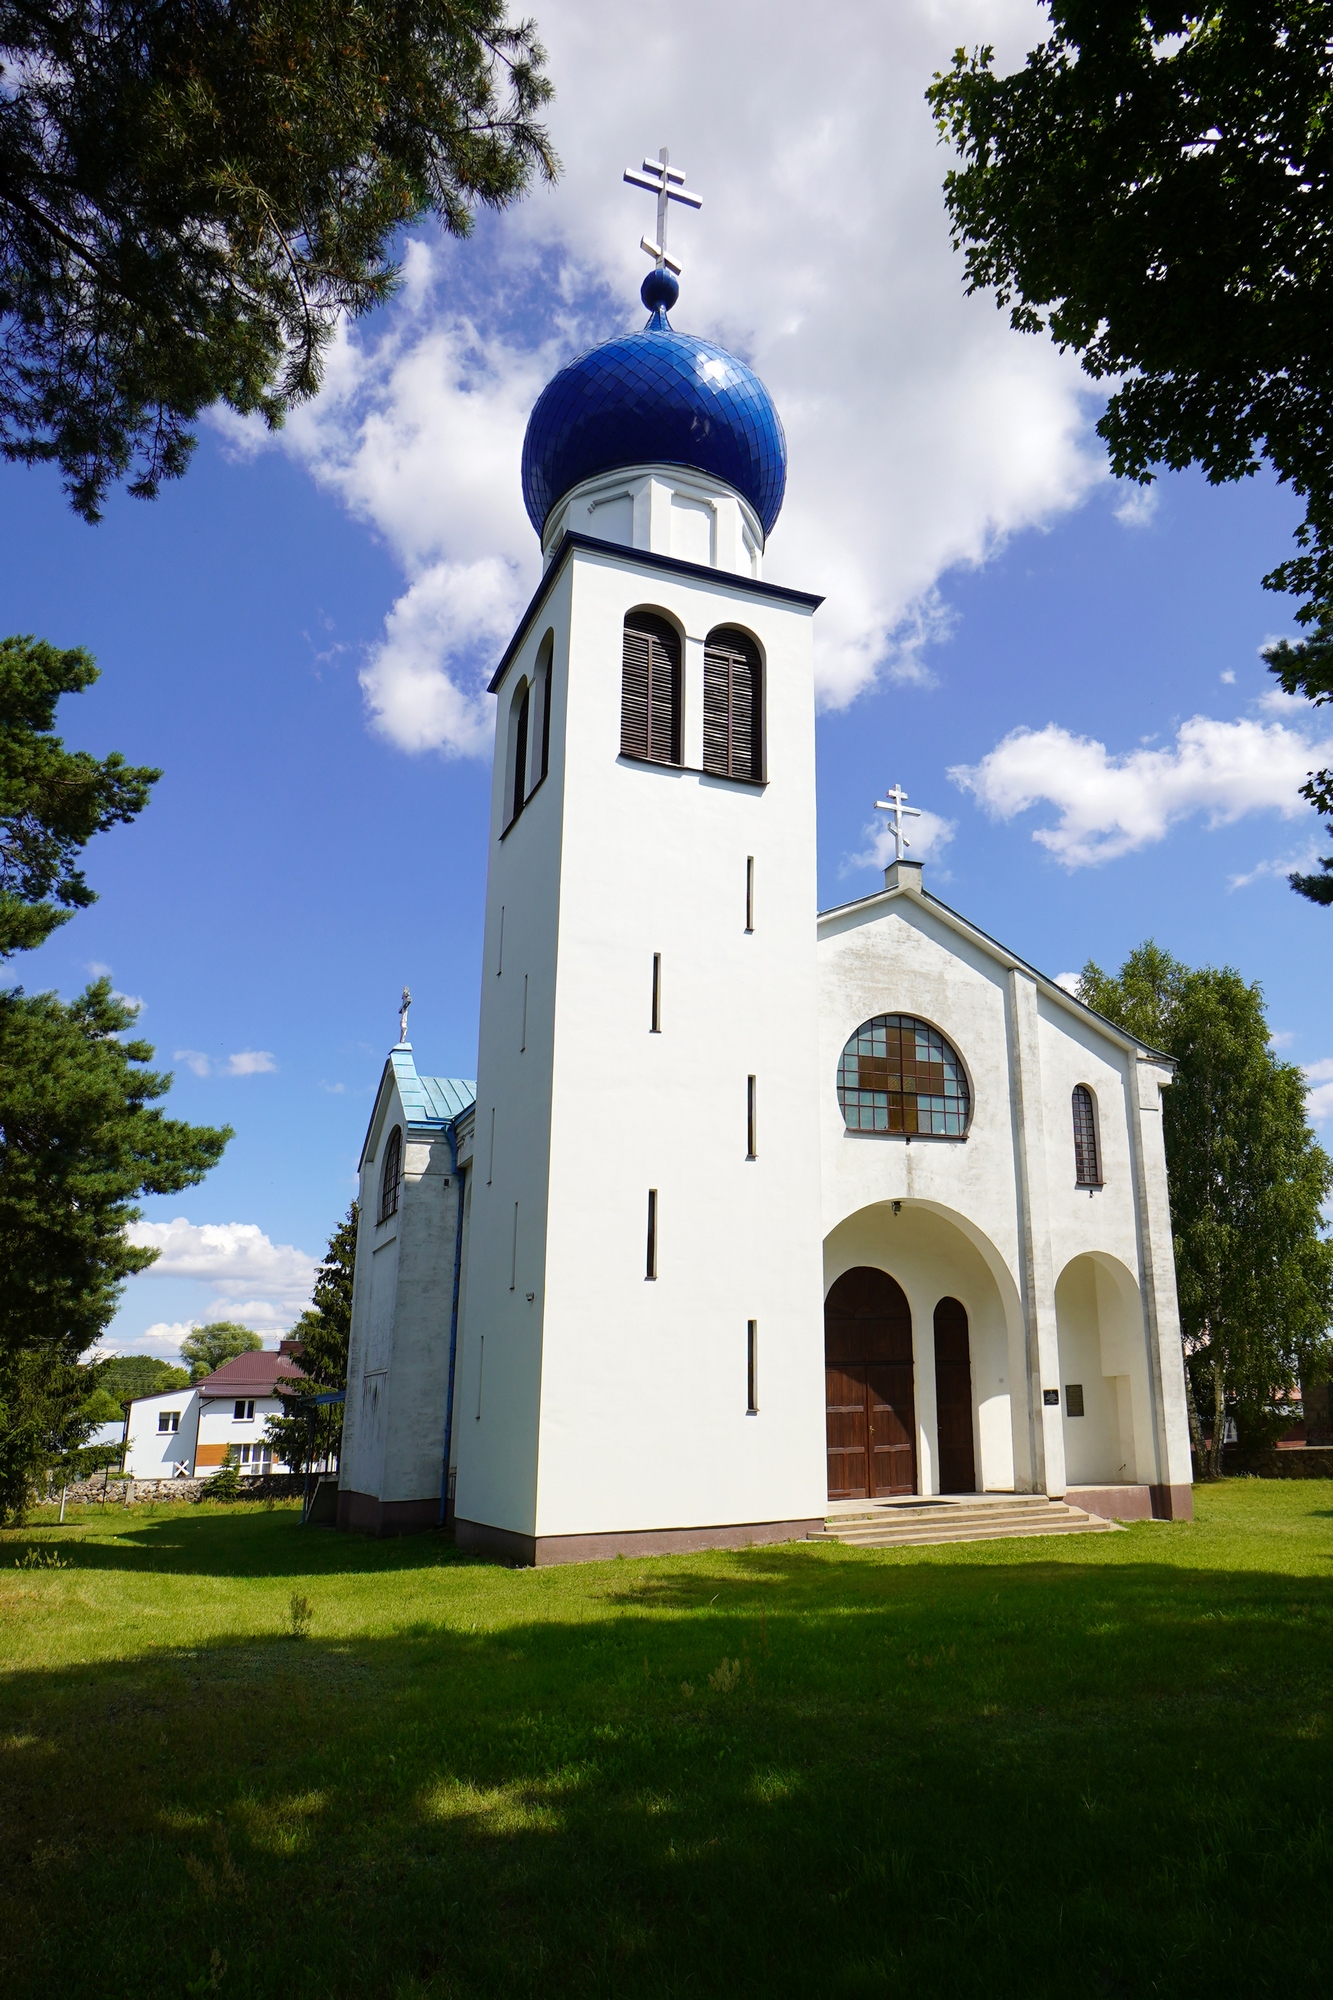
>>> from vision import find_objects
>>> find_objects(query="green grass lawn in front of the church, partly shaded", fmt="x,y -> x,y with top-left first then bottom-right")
0,1480 -> 1333,2000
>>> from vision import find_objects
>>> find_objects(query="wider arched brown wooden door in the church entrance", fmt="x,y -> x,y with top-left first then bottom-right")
825,1264 -> 917,1500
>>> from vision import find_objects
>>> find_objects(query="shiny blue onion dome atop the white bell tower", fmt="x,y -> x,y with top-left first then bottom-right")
522,270 -> 787,536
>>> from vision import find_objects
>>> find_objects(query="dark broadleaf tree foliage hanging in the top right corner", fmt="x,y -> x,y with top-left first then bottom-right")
927,0 -> 1333,904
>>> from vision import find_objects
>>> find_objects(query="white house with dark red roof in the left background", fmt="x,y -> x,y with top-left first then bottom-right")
124,1340 -> 300,1480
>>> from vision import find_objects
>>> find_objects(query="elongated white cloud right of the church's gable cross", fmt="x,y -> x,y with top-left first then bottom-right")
949,716 -> 1333,868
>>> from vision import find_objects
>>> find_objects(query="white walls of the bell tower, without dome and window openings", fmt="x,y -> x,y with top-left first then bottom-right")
456,524 -> 825,1536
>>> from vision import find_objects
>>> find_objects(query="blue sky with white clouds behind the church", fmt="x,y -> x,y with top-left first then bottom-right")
0,8 -> 1333,1352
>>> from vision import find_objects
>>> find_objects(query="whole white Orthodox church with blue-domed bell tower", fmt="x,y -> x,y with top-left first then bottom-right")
338,158 -> 1191,1564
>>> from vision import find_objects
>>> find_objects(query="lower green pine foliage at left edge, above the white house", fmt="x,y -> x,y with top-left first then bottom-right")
0,980 -> 230,1360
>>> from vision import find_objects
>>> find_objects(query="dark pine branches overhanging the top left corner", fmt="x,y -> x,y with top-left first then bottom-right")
0,0 -> 556,520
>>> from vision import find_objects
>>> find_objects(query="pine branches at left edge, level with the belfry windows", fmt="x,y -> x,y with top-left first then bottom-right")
0,636 -> 162,958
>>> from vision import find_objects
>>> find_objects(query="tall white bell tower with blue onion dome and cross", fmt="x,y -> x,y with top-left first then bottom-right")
454,168 -> 827,1562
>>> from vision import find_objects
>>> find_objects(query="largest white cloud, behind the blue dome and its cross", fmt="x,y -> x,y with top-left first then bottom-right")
222,0 -> 1105,754
